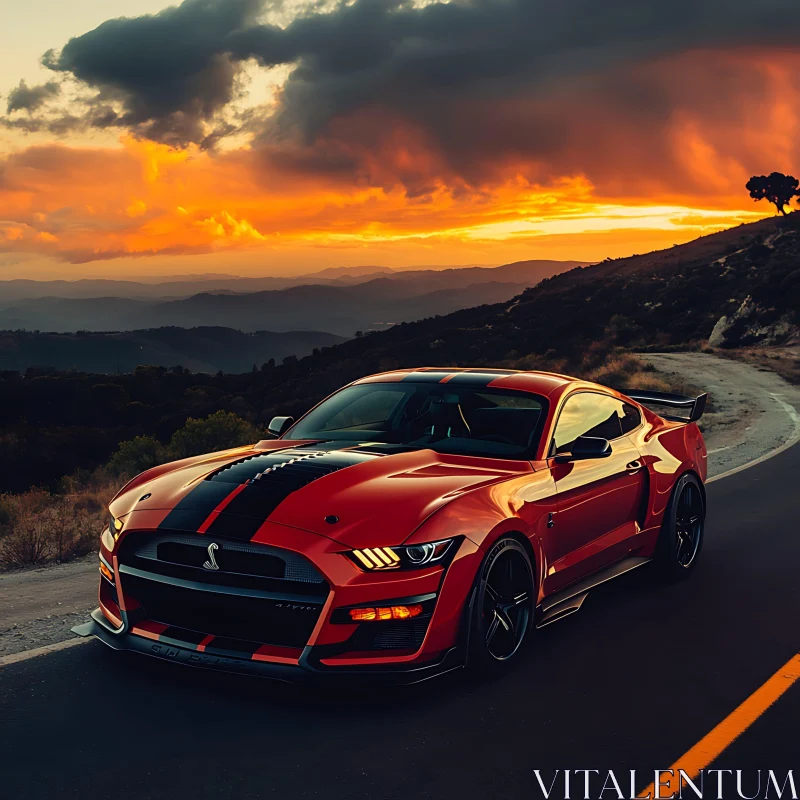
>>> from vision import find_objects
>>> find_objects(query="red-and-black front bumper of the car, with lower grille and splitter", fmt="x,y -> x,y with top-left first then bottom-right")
79,525 -> 480,683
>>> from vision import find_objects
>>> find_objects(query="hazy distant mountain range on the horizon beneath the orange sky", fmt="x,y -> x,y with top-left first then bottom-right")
0,261 -> 579,336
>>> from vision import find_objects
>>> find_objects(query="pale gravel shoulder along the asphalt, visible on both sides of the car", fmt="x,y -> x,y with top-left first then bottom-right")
0,353 -> 800,664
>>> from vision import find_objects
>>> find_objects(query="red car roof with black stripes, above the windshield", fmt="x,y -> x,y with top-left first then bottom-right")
353,367 -> 584,396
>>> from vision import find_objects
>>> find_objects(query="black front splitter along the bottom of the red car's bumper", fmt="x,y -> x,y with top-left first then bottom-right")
72,608 -> 465,685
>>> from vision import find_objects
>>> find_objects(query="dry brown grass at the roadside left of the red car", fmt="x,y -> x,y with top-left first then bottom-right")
0,486 -> 114,568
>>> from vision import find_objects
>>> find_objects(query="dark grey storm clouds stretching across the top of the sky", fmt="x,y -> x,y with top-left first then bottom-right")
14,0 -> 800,161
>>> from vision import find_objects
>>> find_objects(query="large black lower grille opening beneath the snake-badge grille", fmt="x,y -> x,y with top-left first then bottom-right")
122,574 -> 322,647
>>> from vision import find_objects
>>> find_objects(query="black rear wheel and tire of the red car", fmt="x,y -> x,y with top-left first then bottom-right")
654,473 -> 706,581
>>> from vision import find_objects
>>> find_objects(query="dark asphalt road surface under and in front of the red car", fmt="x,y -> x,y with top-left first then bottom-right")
0,445 -> 800,800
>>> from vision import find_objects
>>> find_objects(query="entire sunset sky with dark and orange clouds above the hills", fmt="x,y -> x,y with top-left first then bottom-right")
0,0 -> 800,279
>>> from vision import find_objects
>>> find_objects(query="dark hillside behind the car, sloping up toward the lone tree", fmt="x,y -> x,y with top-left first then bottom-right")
255,211 -> 800,388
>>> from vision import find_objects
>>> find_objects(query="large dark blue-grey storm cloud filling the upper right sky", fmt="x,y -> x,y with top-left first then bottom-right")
238,0 -> 800,141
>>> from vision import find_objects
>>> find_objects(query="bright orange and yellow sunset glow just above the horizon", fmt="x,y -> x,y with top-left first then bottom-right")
0,136 -> 767,272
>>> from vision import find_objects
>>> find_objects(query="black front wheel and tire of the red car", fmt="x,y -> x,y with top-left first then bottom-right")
467,537 -> 536,673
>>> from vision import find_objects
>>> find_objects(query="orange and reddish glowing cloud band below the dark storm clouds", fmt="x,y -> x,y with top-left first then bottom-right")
0,47 -> 800,269
